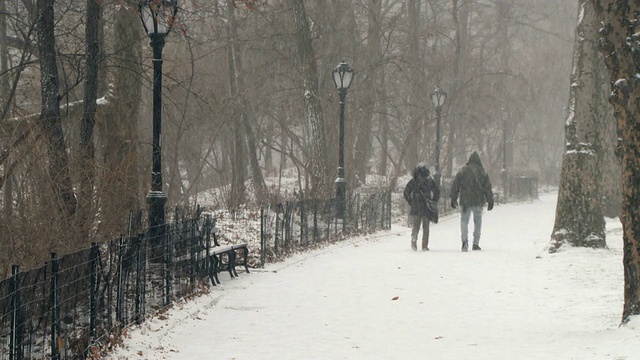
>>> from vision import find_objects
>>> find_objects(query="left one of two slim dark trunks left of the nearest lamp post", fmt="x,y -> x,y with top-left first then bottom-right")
36,0 -> 76,221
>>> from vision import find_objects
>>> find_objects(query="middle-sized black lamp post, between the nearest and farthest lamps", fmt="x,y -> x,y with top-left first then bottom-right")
333,60 -> 355,225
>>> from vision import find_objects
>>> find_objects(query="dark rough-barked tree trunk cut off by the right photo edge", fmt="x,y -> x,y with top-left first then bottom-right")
589,0 -> 640,324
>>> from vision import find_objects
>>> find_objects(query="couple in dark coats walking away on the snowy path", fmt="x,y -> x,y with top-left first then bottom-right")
403,151 -> 493,252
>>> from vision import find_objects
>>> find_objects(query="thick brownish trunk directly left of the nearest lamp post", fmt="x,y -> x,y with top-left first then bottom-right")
96,3 -> 142,236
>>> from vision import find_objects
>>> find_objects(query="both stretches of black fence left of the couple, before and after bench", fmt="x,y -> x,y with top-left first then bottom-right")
0,192 -> 391,360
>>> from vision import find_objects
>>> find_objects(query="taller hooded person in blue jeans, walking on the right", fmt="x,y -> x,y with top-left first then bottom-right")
451,151 -> 493,252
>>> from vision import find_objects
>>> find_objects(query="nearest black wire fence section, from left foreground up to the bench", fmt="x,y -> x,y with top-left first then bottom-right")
0,207 -> 210,360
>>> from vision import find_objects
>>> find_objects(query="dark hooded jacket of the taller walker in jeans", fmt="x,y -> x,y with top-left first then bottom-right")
451,151 -> 493,208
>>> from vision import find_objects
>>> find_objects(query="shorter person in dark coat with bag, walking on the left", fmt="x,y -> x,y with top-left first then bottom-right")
403,164 -> 440,251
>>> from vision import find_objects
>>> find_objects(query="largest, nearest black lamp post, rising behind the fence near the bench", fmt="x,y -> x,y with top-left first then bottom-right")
138,0 -> 178,238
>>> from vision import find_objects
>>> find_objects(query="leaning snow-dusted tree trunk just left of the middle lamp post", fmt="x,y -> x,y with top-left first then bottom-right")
291,0 -> 331,198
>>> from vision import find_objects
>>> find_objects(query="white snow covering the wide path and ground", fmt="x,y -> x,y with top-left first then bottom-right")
107,194 -> 640,360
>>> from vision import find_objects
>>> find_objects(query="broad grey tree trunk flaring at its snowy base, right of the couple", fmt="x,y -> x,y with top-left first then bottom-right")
549,0 -> 606,253
